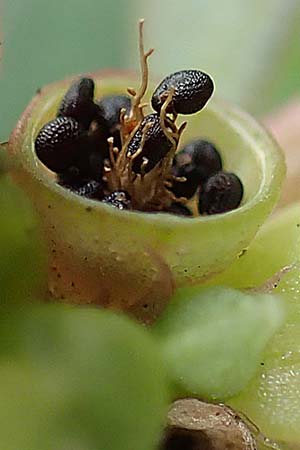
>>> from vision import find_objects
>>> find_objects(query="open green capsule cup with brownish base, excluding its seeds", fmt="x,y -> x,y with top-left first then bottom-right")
9,72 -> 285,322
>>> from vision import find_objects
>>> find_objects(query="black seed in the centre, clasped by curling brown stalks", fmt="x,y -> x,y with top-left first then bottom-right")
127,114 -> 172,173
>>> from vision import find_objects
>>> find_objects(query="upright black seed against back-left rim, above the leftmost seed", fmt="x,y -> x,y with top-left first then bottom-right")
57,78 -> 98,128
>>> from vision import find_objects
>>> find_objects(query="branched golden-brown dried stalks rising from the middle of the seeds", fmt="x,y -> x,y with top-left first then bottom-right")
105,20 -> 186,211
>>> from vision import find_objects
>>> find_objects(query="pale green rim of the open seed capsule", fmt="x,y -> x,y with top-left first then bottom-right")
10,71 -> 285,227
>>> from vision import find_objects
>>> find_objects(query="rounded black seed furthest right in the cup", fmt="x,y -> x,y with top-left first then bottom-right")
198,171 -> 244,214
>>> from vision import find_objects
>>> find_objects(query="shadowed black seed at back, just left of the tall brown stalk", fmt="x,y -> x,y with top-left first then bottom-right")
96,95 -> 131,148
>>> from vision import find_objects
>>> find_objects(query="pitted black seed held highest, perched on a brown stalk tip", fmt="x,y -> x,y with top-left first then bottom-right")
151,70 -> 214,114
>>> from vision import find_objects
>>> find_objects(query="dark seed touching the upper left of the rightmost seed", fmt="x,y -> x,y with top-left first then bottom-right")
172,139 -> 222,198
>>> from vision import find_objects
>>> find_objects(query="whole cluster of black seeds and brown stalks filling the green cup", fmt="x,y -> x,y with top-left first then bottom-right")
35,23 -> 243,217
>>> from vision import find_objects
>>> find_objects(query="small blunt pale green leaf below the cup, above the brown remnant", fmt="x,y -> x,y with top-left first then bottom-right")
154,287 -> 284,401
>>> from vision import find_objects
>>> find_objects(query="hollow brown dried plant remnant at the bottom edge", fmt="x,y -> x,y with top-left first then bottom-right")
160,399 -> 257,450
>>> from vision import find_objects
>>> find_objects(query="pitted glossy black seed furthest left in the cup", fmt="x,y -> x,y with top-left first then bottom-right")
35,117 -> 85,173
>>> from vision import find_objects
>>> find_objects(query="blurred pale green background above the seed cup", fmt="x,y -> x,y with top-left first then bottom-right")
0,0 -> 300,140
